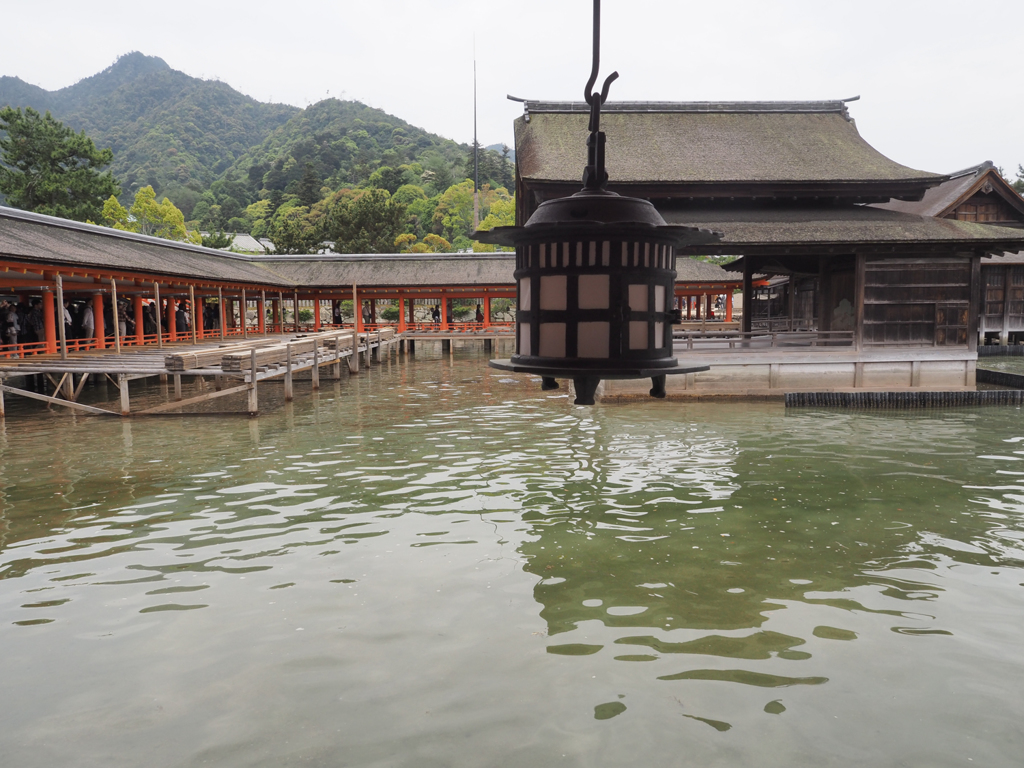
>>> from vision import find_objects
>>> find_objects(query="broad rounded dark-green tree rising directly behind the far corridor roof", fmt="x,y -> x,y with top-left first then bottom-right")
326,188 -> 406,253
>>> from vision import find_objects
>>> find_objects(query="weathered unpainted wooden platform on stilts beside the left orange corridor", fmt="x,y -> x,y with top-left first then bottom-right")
0,329 -> 399,419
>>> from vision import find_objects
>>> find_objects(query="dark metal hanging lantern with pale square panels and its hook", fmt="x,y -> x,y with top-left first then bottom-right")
473,0 -> 721,406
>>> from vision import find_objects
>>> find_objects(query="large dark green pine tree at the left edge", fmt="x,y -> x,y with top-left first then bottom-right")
0,106 -> 121,221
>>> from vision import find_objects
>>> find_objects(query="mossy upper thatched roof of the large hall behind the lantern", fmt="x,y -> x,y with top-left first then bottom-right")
515,101 -> 946,198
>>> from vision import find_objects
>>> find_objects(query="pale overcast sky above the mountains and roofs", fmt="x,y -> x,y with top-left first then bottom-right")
0,0 -> 1024,178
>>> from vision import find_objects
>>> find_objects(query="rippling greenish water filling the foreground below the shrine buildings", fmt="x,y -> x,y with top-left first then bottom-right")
0,352 -> 1024,768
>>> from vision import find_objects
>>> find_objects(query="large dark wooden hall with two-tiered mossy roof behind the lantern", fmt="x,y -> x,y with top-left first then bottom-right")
515,100 -> 1024,392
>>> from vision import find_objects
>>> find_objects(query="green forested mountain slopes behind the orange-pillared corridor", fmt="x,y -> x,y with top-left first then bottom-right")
0,53 -> 514,248
